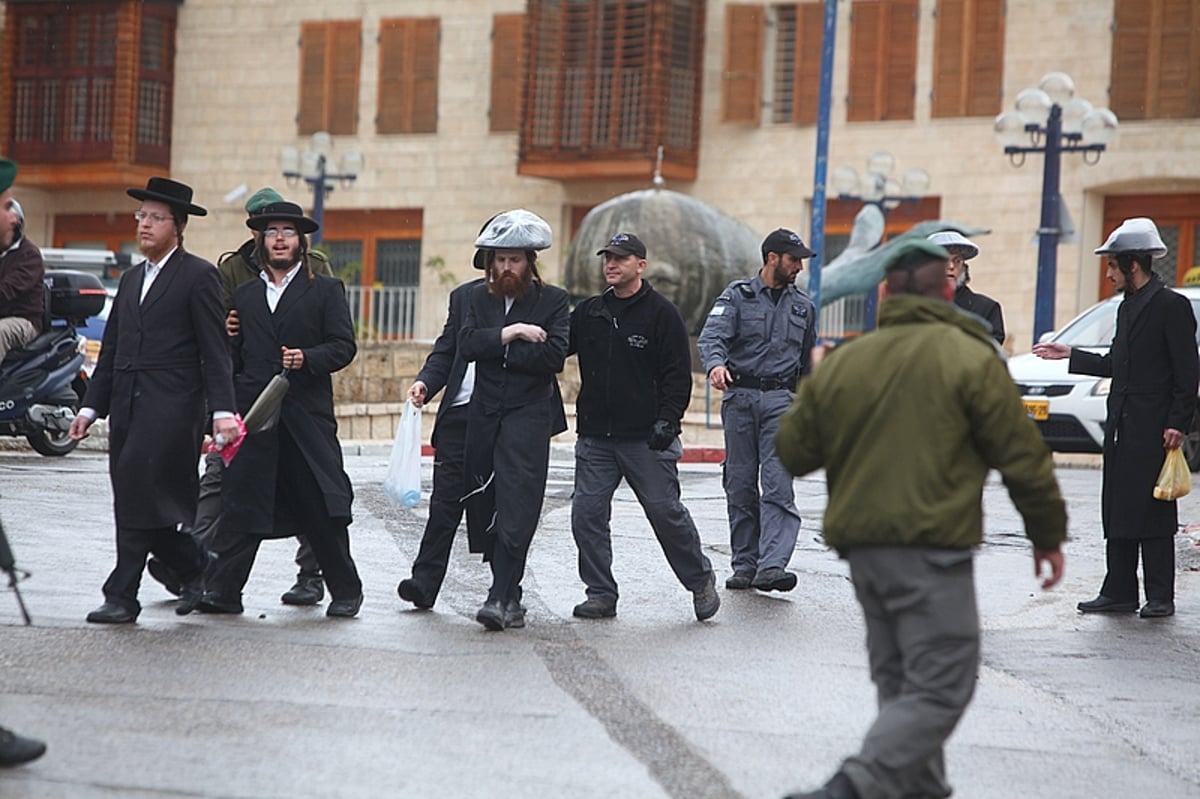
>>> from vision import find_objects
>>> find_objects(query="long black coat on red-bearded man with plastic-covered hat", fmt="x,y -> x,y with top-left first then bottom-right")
458,283 -> 571,555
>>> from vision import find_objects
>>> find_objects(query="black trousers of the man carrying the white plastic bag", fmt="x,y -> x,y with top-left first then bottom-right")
413,405 -> 468,602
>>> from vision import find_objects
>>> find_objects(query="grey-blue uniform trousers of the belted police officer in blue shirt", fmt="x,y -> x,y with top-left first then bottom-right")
721,389 -> 800,572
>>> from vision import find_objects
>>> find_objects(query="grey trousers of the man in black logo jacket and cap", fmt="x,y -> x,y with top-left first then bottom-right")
571,437 -> 713,602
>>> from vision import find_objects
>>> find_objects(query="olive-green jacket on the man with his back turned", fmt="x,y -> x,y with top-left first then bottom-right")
775,295 -> 1067,551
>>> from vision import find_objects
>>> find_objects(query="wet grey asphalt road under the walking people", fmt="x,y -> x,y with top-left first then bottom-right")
0,445 -> 1200,799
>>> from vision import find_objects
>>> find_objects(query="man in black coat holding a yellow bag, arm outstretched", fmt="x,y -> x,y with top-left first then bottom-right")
1033,217 -> 1200,618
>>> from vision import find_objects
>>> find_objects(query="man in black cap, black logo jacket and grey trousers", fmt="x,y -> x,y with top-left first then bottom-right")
570,233 -> 721,621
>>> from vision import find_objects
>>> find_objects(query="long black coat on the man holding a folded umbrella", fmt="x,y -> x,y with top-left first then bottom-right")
221,270 -> 358,537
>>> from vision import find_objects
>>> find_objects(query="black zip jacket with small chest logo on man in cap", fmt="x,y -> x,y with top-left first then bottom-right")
570,281 -> 691,438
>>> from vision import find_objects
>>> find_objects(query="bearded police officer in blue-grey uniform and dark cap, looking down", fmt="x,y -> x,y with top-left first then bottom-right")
697,228 -> 816,591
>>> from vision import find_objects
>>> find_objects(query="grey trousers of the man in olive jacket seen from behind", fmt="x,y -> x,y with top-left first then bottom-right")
841,546 -> 979,799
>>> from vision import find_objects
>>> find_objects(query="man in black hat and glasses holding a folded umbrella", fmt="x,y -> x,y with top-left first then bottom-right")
184,202 -> 362,618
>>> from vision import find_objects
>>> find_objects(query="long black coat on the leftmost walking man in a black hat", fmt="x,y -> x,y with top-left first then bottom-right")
83,250 -> 234,529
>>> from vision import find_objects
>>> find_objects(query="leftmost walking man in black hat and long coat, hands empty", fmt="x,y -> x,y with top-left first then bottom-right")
71,178 -> 238,624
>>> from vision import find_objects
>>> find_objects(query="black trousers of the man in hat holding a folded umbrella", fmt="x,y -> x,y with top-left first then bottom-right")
204,428 -> 362,601
